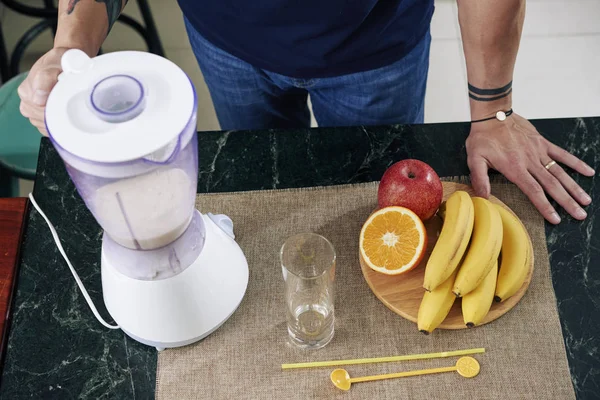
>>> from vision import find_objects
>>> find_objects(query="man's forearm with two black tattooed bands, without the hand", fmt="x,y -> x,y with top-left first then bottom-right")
457,0 -> 525,119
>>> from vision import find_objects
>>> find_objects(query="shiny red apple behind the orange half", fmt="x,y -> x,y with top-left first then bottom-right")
377,159 -> 443,221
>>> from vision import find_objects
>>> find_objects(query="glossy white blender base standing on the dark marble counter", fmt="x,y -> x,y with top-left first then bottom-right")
102,211 -> 249,350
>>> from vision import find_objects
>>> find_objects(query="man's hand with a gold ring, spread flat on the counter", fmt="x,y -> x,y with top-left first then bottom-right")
467,113 -> 595,224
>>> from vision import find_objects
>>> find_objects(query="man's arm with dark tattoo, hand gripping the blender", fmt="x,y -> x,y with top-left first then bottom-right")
19,0 -> 127,134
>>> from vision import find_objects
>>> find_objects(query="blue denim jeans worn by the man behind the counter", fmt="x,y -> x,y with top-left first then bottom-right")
185,19 -> 431,130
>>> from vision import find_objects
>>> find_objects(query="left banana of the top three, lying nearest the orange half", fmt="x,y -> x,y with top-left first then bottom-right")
423,191 -> 474,292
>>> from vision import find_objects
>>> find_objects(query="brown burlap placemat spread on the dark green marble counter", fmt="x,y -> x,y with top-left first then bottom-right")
156,183 -> 575,400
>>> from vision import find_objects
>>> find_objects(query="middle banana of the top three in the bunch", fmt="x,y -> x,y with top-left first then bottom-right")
452,197 -> 503,297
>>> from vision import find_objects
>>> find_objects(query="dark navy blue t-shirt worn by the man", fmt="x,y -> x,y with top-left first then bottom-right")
178,0 -> 434,79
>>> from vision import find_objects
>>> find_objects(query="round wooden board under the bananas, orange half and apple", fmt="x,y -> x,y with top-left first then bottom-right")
359,182 -> 533,329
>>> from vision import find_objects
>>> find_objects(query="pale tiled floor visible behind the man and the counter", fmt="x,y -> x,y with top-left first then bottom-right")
0,0 -> 600,195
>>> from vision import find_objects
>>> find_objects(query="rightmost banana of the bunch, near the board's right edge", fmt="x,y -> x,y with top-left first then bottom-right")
495,206 -> 533,302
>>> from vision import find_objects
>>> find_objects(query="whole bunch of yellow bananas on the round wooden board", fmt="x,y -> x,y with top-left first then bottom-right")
418,191 -> 533,333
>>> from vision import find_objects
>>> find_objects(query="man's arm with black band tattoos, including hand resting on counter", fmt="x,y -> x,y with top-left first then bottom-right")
457,0 -> 594,224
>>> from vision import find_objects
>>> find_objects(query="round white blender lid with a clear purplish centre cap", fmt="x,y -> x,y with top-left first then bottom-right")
46,49 -> 196,163
